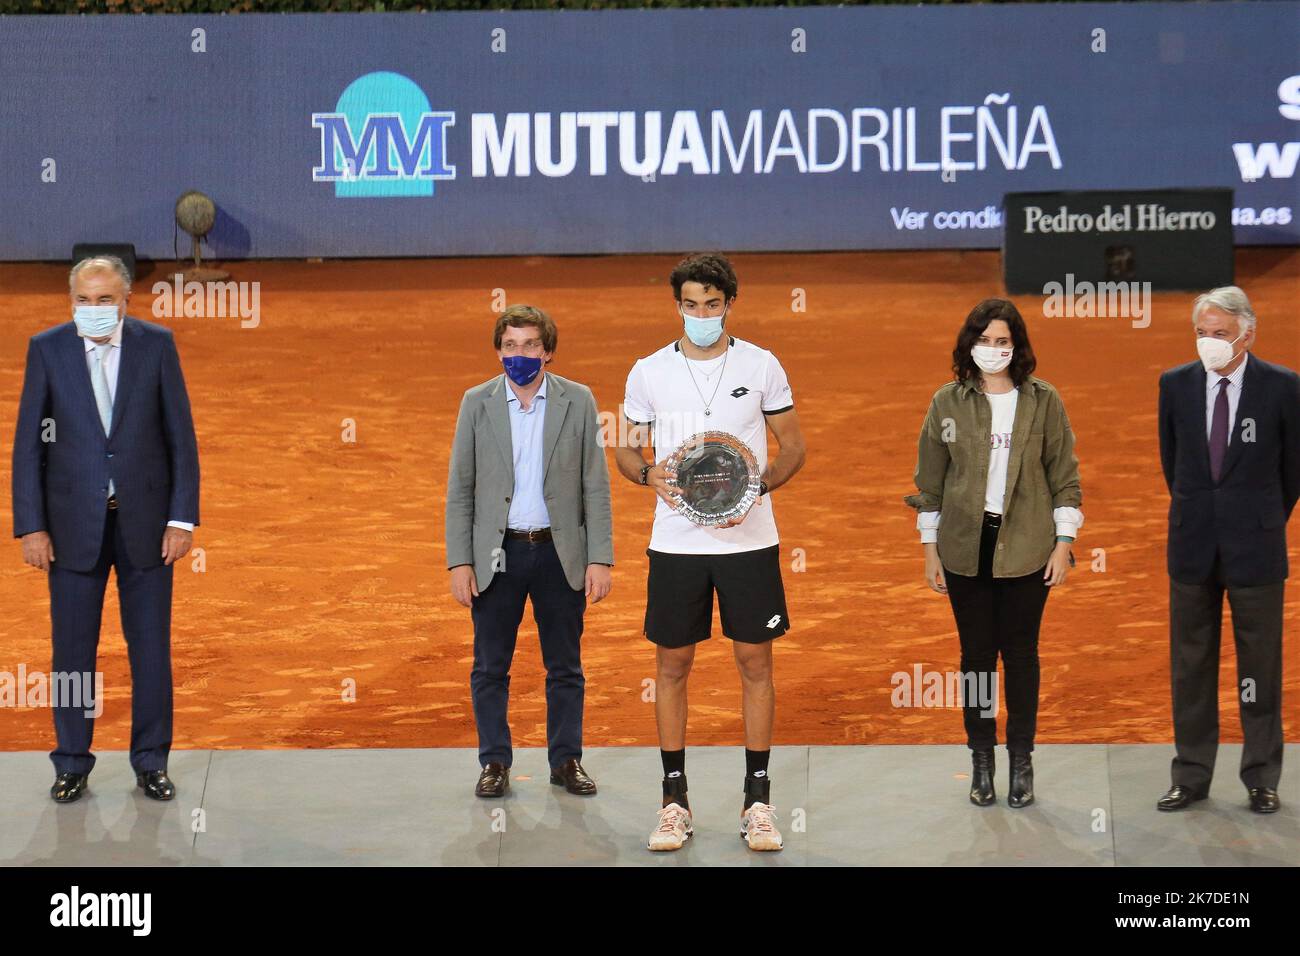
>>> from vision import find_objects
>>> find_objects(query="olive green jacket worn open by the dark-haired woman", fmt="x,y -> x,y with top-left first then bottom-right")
904,375 -> 1083,578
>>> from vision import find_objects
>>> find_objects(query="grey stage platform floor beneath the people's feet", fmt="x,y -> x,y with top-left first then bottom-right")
0,745 -> 1300,866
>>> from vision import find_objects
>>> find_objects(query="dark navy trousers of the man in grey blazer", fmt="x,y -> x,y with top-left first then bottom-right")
469,537 -> 586,767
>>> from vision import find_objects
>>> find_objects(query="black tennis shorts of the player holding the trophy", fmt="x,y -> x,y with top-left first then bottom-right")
645,545 -> 790,648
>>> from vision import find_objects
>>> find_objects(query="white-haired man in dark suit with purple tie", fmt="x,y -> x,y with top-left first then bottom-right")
1156,286 -> 1300,813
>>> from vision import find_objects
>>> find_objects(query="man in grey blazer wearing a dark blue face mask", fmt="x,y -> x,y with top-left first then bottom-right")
446,306 -> 614,797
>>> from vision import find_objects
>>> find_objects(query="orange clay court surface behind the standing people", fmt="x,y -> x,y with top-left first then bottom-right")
0,248 -> 1300,750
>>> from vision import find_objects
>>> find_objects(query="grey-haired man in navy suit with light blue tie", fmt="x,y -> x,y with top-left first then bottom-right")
13,256 -> 199,803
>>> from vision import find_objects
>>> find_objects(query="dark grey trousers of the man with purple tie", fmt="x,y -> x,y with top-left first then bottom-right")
1169,555 -> 1286,792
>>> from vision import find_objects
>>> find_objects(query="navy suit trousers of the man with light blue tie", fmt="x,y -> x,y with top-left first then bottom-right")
49,509 -> 174,774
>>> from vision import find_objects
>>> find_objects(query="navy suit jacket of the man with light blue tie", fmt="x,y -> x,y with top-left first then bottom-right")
13,316 -> 199,571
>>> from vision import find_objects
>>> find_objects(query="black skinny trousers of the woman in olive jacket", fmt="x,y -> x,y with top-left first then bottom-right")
944,511 -> 1052,753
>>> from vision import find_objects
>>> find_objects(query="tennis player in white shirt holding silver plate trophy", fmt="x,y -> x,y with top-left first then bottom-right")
616,255 -> 803,851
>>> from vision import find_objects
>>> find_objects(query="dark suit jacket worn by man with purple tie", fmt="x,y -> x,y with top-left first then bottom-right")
1160,354 -> 1300,587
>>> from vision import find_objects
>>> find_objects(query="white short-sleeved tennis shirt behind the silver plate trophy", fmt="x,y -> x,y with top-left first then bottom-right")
623,336 -> 794,554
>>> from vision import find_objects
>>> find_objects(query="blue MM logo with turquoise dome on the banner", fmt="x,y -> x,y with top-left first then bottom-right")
312,72 -> 456,196
